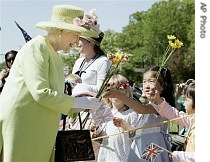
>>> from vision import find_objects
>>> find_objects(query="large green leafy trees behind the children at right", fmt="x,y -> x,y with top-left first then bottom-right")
102,0 -> 195,82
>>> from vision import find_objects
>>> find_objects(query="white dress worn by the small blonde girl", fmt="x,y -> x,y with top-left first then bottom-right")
97,109 -> 138,162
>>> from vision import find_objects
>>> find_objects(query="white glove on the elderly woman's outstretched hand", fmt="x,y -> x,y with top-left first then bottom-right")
72,97 -> 103,111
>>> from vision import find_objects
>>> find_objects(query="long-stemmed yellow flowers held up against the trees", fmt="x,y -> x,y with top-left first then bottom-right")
155,35 -> 183,83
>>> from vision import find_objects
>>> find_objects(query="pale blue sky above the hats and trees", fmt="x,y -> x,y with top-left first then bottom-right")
0,0 -> 158,61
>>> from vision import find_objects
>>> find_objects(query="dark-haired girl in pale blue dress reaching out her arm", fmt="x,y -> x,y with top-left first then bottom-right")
103,66 -> 175,162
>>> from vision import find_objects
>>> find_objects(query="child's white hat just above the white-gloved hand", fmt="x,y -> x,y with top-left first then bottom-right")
72,83 -> 97,97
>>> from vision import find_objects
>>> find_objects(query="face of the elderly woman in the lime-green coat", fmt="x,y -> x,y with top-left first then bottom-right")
60,31 -> 80,52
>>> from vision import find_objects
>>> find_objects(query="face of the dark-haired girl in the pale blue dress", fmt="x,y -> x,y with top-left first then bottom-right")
143,71 -> 163,99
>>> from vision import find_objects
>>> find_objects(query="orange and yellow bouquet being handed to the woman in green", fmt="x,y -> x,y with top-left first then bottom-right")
96,51 -> 128,98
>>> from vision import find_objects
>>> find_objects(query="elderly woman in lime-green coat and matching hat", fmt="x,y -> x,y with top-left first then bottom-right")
0,5 -> 101,162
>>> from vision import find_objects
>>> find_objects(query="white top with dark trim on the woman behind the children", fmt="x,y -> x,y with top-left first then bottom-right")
72,55 -> 110,91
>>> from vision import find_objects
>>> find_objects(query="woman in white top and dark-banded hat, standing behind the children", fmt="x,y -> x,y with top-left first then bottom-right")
72,10 -> 110,92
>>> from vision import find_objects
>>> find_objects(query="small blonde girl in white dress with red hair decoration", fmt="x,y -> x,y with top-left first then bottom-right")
92,74 -> 138,162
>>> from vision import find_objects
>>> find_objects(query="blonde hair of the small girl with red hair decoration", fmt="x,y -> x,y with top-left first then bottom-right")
103,74 -> 133,108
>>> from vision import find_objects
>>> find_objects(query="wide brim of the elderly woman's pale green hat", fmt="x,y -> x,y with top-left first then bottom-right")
36,21 -> 98,38
